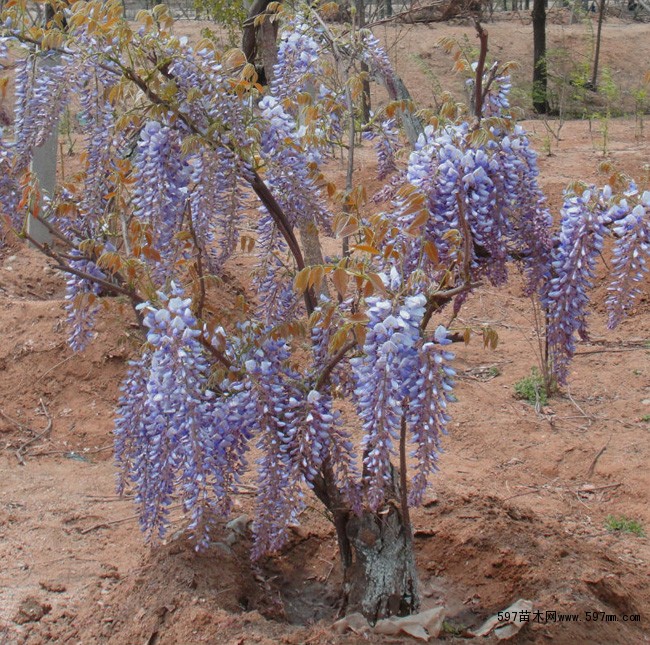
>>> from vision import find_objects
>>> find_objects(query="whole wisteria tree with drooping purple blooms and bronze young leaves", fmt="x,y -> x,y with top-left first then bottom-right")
0,0 -> 650,620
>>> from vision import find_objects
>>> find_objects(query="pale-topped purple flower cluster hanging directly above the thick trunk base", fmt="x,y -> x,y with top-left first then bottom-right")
351,270 -> 454,510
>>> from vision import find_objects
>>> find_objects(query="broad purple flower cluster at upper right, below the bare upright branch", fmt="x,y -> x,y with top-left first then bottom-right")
378,72 -> 553,292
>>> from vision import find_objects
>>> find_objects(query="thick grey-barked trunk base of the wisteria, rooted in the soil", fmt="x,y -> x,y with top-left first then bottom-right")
343,504 -> 420,624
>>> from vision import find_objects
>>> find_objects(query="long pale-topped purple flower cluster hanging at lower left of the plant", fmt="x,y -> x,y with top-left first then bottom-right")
115,285 -> 227,544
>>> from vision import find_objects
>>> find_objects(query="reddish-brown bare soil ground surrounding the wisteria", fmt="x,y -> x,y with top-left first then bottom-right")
0,11 -> 650,645
